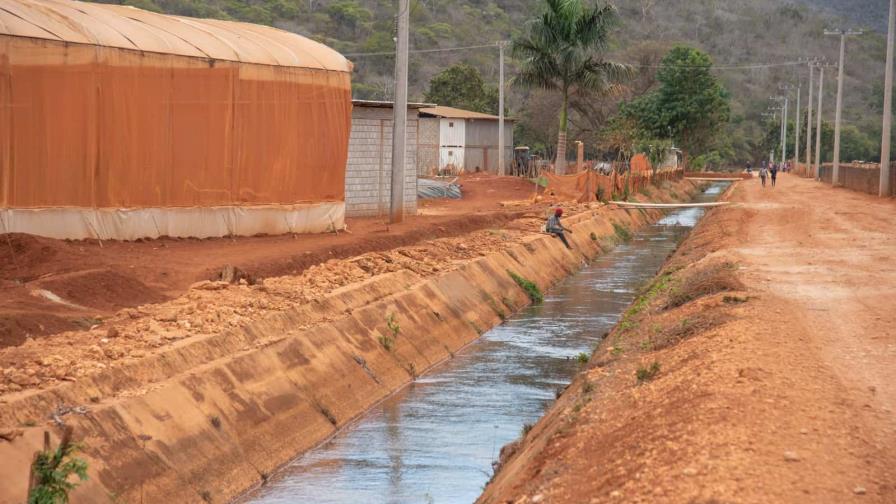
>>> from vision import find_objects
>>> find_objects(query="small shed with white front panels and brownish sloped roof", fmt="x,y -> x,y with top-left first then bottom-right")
417,106 -> 513,176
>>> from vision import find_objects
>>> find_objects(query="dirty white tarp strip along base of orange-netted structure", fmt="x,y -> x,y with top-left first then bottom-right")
0,201 -> 345,240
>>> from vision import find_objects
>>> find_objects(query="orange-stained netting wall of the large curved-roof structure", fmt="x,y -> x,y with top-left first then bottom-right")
0,0 -> 351,208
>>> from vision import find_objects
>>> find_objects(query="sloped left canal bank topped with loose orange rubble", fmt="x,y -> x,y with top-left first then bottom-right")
0,181 -> 696,503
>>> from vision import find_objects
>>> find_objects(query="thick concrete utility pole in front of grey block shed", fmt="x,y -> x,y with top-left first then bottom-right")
389,0 -> 410,224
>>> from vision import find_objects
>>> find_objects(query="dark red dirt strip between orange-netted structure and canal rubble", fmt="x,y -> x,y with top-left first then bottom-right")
0,174 -> 546,348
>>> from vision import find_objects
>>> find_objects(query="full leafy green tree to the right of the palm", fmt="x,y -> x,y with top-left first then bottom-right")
626,46 -> 731,166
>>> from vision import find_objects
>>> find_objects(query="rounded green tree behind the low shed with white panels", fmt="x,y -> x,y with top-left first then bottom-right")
424,63 -> 498,114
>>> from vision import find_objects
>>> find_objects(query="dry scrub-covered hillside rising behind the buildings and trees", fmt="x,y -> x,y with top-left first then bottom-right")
94,0 -> 887,159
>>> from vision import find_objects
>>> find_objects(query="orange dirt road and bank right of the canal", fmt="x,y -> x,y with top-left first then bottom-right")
480,175 -> 896,504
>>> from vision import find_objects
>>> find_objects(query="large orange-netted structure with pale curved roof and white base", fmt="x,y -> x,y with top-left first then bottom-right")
0,0 -> 352,239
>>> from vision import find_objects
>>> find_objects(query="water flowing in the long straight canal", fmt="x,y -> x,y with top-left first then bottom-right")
245,184 -> 725,504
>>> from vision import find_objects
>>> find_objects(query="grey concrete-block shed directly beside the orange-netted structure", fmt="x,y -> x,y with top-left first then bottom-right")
345,100 -> 430,217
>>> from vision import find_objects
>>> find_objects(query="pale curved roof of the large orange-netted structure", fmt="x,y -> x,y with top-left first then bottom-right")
0,0 -> 351,72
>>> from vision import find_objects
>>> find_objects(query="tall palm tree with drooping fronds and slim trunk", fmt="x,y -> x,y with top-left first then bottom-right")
513,0 -> 631,174
